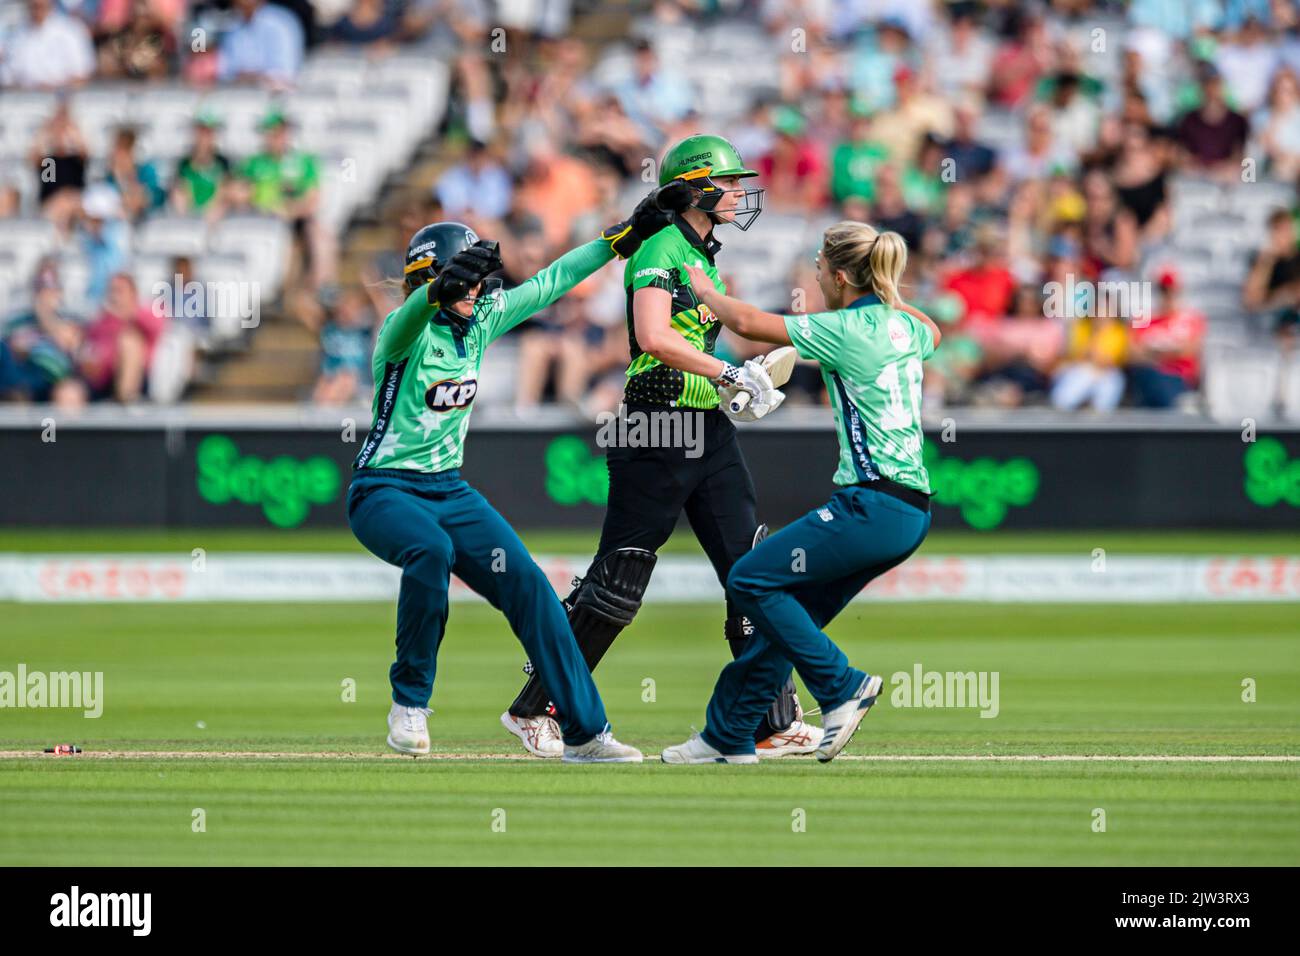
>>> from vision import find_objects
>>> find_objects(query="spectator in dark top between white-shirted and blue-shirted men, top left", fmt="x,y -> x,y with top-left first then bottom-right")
94,0 -> 186,79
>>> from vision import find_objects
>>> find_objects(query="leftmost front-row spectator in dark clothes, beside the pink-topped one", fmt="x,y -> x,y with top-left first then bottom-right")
0,259 -> 87,408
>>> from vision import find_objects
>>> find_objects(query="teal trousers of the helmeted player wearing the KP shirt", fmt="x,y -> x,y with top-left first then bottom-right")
347,468 -> 608,745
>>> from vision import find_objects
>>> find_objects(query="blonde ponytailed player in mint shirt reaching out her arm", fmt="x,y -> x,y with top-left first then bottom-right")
662,222 -> 940,763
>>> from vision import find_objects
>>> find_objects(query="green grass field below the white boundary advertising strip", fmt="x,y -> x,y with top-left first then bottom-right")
0,605 -> 1300,865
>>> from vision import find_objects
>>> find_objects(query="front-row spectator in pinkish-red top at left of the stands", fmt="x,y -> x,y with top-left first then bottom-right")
81,272 -> 168,405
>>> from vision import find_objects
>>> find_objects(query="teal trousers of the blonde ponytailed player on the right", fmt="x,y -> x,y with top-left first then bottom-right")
701,485 -> 930,754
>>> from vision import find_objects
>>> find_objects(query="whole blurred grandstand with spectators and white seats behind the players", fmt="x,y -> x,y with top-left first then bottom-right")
0,0 -> 1300,419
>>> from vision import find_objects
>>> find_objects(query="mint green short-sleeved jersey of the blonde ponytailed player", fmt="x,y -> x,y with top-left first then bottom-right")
785,295 -> 935,494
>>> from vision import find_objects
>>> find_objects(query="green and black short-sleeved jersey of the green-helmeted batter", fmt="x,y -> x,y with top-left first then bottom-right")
623,217 -> 727,408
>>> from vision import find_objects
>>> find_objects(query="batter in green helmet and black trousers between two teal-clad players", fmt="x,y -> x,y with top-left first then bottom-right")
502,135 -> 820,757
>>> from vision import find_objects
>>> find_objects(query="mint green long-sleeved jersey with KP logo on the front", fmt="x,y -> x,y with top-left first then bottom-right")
352,239 -> 614,472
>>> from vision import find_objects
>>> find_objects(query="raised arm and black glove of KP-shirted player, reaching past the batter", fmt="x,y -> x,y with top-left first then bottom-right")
490,179 -> 694,338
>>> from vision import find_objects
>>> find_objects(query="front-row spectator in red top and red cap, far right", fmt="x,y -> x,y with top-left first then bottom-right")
1128,269 -> 1205,408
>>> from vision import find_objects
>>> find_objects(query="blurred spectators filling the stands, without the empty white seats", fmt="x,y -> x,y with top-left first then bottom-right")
0,0 -> 1300,414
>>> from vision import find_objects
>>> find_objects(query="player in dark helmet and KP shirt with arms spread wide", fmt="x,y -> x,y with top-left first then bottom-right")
347,179 -> 692,762
